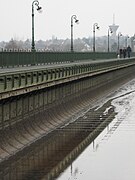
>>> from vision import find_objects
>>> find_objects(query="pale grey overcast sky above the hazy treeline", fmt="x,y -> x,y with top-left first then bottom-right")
0,0 -> 135,41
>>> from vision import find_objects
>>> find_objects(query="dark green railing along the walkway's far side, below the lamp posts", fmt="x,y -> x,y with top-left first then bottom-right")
0,51 -> 117,68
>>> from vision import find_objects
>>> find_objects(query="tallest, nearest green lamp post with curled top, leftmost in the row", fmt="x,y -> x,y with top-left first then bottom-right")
31,0 -> 42,51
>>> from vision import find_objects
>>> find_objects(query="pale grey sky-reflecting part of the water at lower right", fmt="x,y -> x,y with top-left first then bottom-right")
58,80 -> 135,180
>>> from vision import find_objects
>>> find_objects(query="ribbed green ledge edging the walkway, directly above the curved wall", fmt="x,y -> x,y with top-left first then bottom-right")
0,58 -> 135,99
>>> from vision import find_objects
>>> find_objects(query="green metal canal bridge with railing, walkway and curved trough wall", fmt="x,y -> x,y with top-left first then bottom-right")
0,51 -> 135,170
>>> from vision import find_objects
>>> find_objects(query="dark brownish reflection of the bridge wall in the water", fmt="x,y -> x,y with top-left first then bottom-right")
0,101 -> 116,180
